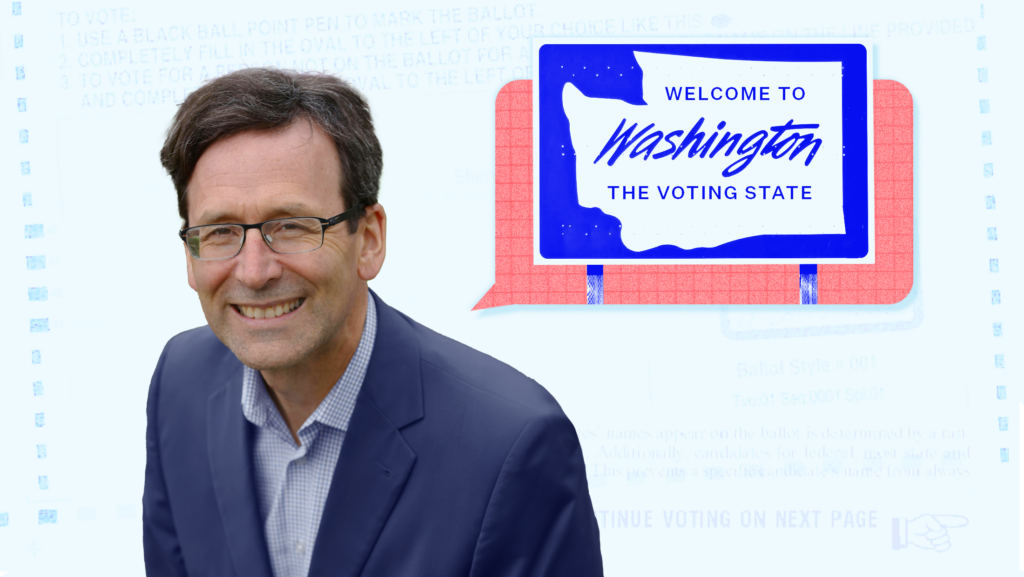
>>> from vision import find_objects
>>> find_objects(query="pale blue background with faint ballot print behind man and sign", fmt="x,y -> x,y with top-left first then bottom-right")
0,0 -> 1024,577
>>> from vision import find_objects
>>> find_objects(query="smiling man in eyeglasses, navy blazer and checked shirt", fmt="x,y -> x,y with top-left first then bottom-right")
142,69 -> 601,577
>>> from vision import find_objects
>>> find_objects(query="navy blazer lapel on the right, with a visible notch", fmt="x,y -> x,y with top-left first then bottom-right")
308,291 -> 423,577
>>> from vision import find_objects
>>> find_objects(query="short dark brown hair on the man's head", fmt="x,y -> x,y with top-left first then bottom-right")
160,68 -> 384,233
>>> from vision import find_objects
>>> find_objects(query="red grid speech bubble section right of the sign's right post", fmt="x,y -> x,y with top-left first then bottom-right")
818,80 -> 913,304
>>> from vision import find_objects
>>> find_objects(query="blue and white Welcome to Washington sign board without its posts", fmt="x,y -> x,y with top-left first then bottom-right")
534,39 -> 874,264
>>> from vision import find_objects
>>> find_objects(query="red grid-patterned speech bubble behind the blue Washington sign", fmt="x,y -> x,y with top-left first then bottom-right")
473,80 -> 913,311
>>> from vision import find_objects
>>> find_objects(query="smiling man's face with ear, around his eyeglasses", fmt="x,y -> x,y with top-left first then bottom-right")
185,120 -> 383,370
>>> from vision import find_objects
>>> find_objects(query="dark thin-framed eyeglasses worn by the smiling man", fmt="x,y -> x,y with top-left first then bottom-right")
178,204 -> 362,260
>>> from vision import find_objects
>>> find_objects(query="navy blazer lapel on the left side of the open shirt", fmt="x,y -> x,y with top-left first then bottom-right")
206,364 -> 272,577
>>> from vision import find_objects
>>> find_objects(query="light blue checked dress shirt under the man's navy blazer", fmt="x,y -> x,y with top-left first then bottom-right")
242,292 -> 377,577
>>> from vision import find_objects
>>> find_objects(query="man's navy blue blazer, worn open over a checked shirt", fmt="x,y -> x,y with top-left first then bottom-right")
142,293 -> 602,577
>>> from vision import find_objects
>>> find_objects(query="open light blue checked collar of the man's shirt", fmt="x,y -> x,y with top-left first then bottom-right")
242,291 -> 377,430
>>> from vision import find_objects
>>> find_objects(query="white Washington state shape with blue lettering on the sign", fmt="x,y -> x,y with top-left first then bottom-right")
562,52 -> 846,251
